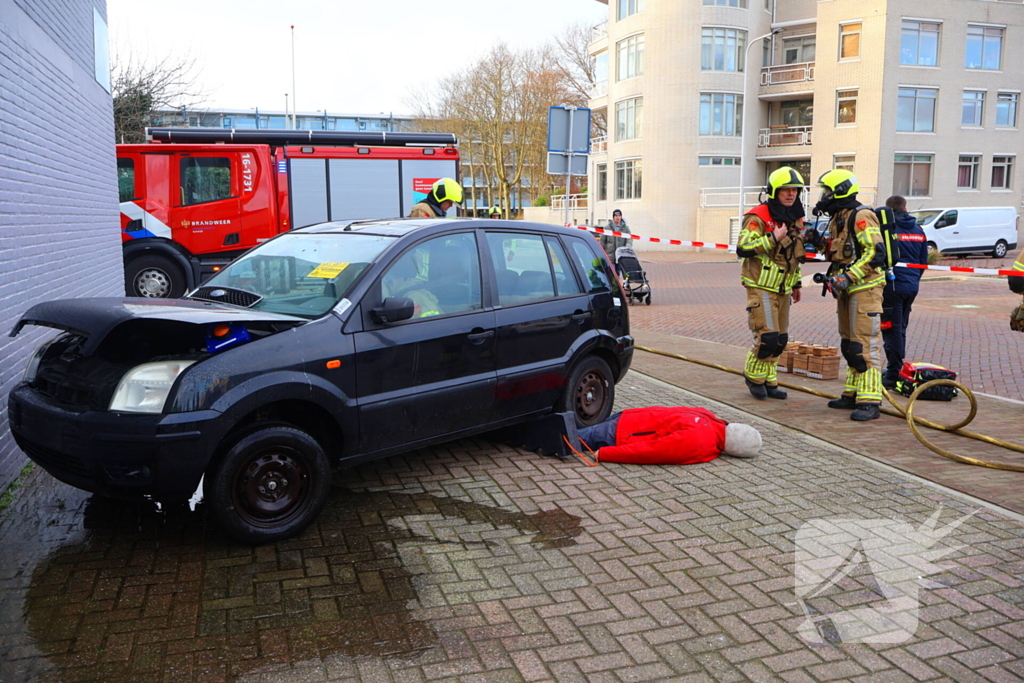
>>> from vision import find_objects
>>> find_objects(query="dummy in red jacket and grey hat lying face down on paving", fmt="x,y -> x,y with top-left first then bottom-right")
578,407 -> 761,465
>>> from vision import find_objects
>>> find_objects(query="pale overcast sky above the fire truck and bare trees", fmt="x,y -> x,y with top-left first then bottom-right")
106,0 -> 607,114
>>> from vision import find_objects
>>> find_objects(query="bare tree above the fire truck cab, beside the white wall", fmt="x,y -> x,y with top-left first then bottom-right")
111,54 -> 204,142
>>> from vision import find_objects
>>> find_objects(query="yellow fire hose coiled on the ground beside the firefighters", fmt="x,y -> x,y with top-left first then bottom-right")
636,345 -> 1024,472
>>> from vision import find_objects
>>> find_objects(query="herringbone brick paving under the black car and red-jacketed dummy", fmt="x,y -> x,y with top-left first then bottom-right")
0,374 -> 1024,683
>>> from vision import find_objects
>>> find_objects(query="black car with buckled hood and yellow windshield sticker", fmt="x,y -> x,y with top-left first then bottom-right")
8,219 -> 633,543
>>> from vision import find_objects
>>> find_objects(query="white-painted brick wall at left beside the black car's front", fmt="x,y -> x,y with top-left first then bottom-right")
0,0 -> 124,490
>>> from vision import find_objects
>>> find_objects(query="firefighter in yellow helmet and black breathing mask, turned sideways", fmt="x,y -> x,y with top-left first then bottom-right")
808,169 -> 886,422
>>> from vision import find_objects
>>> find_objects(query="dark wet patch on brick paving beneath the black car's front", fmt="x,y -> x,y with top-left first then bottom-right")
0,485 -> 583,683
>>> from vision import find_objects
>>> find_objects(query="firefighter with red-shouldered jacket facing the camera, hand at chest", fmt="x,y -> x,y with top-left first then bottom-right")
736,166 -> 805,399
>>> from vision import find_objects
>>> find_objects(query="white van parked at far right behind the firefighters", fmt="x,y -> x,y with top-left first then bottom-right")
910,206 -> 1017,258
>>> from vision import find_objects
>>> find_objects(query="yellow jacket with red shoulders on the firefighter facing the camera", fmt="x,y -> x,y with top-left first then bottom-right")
736,204 -> 805,294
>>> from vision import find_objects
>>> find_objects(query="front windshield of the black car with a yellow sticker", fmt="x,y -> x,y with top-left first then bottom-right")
198,233 -> 395,318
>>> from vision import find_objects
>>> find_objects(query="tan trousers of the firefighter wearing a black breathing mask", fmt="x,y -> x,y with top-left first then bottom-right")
837,285 -> 883,403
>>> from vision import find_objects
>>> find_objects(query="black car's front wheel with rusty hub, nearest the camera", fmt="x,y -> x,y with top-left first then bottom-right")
204,426 -> 331,545
